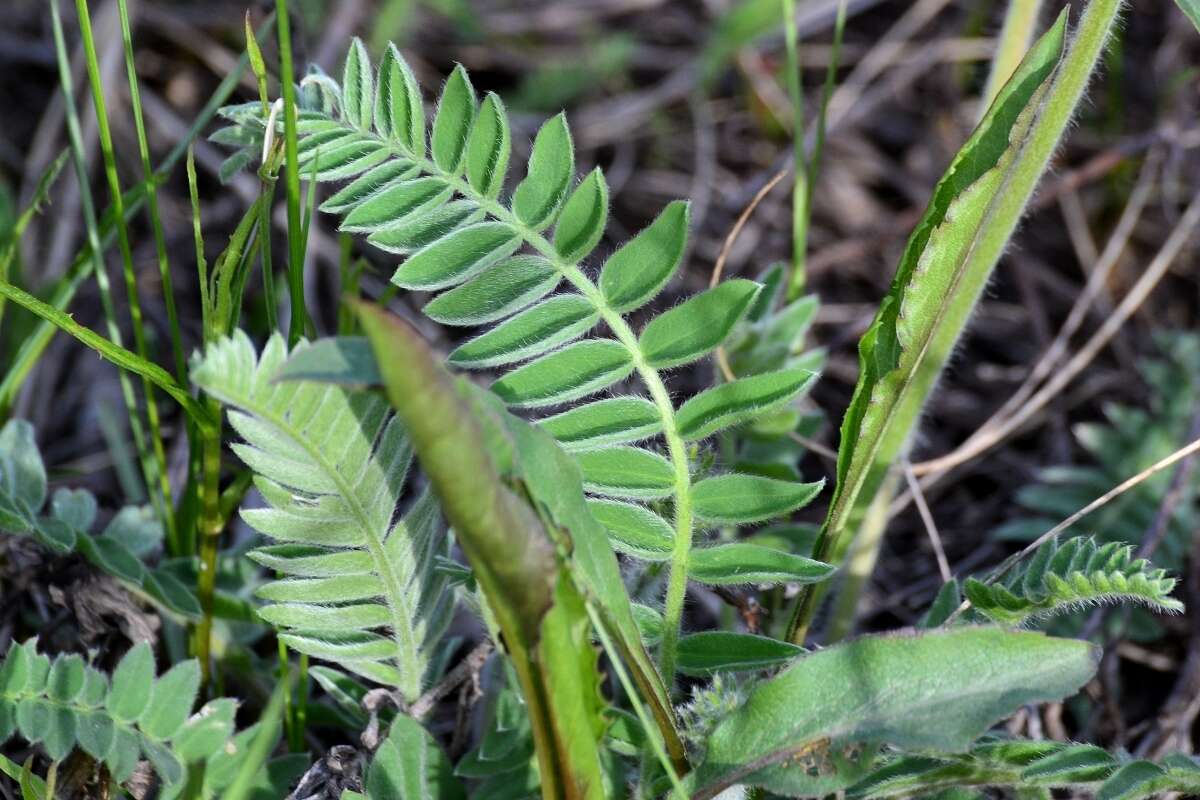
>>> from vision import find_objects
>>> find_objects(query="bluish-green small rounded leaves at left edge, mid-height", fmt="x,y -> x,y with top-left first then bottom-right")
0,420 -> 200,619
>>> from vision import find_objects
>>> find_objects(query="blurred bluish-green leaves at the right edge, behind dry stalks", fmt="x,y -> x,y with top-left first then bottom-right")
996,332 -> 1200,570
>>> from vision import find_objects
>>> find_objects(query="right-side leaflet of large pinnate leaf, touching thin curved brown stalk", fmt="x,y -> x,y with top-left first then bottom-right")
638,278 -> 758,368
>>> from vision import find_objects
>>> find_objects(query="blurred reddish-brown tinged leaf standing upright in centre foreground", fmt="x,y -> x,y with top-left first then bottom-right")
356,303 -> 606,800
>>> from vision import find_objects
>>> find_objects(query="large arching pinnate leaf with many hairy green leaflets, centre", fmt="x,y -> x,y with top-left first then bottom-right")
216,40 -> 820,680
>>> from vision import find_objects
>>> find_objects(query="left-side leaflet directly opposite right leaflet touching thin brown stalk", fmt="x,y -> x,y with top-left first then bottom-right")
492,339 -> 634,408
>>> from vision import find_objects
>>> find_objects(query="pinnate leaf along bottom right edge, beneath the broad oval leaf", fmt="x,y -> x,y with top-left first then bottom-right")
846,738 -> 1200,800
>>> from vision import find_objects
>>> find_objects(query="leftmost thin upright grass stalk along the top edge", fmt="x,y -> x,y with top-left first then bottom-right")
50,0 -> 154,515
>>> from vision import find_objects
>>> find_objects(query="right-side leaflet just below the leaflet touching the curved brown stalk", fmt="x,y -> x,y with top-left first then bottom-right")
676,368 -> 817,440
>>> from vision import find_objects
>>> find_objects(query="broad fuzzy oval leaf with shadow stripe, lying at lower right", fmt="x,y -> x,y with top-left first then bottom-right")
692,626 -> 1099,800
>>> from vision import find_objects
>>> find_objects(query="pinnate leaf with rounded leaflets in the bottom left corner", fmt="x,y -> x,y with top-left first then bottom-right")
0,639 -> 229,786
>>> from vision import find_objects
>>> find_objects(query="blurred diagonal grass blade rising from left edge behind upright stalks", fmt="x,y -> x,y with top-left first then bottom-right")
0,14 -> 275,414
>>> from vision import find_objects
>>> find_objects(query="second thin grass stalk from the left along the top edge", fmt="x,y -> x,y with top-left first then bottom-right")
76,0 -> 181,555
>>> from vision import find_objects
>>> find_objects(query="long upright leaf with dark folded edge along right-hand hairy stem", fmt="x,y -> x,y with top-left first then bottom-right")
790,8 -> 1084,640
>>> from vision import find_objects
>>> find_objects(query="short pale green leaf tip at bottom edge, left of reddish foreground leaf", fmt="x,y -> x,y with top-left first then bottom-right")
365,715 -> 467,800
